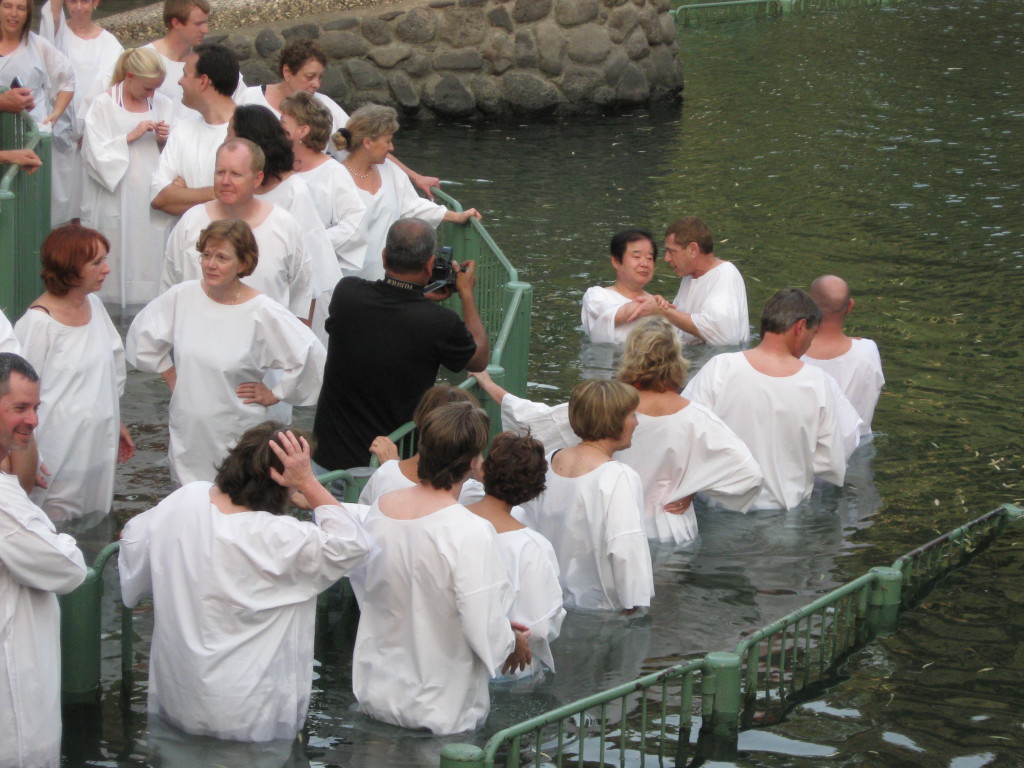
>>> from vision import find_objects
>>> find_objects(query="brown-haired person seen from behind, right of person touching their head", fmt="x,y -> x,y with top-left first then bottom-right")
350,402 -> 530,734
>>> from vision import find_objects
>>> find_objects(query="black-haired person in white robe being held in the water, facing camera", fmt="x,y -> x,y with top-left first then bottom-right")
580,229 -> 667,344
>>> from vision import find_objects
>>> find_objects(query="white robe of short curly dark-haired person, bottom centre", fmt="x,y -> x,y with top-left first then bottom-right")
498,528 -> 565,677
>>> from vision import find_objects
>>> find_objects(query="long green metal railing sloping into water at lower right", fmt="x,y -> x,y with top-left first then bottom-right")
440,505 -> 1024,768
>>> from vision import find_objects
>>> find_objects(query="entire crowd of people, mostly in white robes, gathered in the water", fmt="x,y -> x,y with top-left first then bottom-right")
0,0 -> 884,766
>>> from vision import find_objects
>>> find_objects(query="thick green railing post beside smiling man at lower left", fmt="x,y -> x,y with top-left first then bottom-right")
59,542 -> 121,703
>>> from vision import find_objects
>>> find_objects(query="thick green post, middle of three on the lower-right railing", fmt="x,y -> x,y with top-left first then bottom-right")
700,651 -> 740,760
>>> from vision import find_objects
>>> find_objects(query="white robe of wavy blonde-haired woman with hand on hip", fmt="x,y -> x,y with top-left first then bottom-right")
615,402 -> 762,544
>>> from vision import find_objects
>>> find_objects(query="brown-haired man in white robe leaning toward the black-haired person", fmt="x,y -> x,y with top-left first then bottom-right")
662,216 -> 751,346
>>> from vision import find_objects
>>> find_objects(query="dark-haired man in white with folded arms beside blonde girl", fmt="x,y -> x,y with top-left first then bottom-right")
150,45 -> 239,226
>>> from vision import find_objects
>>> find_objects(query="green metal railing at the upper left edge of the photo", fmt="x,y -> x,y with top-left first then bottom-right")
0,101 -> 50,323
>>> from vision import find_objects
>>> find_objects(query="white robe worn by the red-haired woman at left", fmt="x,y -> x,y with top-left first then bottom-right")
15,294 -> 125,523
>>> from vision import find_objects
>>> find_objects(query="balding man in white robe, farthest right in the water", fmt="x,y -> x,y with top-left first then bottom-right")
801,274 -> 886,442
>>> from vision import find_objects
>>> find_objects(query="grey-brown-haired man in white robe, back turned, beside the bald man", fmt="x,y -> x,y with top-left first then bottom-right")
683,288 -> 859,510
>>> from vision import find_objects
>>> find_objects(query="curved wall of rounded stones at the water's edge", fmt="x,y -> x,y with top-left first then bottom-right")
114,0 -> 683,119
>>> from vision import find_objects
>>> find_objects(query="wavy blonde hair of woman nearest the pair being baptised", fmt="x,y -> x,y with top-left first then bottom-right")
618,317 -> 689,392
